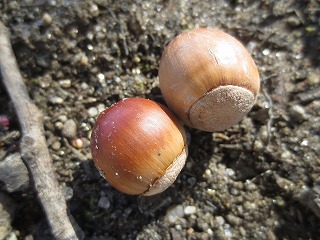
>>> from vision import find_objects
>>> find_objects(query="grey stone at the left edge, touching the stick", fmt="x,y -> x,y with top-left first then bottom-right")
0,153 -> 29,193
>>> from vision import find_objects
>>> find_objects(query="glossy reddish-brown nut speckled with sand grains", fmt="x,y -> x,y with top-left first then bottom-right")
91,98 -> 187,195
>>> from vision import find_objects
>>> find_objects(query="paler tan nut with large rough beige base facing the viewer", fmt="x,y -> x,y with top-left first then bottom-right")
159,28 -> 260,132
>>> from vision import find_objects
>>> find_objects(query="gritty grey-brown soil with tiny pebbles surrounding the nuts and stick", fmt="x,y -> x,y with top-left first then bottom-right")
0,0 -> 320,240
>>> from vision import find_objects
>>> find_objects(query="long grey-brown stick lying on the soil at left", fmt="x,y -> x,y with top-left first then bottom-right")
0,22 -> 78,240
